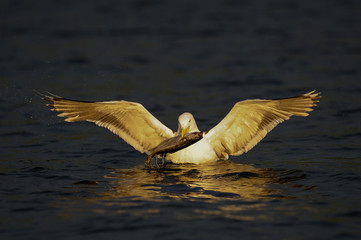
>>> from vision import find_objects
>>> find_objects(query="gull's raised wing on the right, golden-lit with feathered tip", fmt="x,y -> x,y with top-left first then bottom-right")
204,91 -> 321,159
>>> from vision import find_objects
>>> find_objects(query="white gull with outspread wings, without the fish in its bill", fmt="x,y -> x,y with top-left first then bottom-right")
41,90 -> 321,164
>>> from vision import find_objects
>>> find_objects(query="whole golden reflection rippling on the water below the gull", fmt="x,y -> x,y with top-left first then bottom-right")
58,161 -> 312,221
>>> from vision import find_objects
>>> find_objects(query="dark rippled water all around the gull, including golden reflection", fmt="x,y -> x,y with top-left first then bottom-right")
0,0 -> 361,239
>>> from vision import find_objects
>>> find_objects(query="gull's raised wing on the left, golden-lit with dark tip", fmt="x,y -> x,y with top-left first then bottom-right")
42,95 -> 174,154
